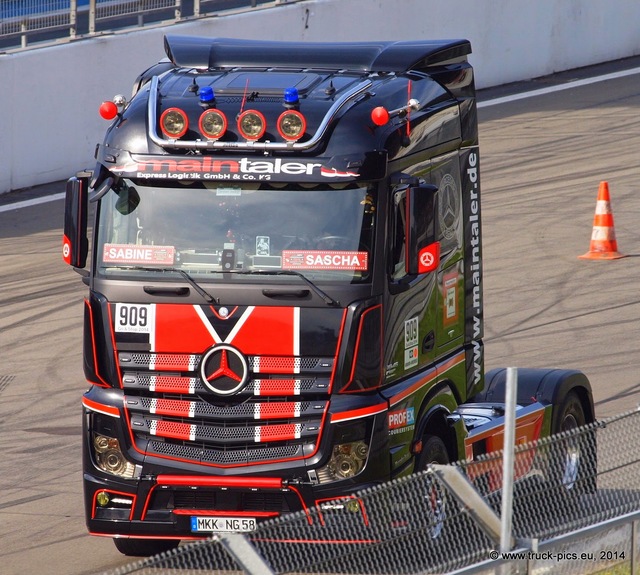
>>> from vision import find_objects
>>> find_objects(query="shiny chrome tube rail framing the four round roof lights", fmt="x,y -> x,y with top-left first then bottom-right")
147,76 -> 373,150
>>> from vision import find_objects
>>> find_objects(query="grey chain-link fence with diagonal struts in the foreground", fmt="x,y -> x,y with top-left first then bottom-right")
96,411 -> 640,575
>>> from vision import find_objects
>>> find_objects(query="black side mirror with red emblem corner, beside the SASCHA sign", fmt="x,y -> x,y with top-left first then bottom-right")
405,185 -> 440,275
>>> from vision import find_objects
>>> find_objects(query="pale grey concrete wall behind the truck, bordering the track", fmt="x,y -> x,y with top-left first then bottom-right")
0,0 -> 640,193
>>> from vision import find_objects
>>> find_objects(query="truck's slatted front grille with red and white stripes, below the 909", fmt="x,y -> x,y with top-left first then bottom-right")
119,352 -> 333,467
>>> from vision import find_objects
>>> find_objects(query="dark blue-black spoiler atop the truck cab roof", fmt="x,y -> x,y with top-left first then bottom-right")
164,35 -> 471,73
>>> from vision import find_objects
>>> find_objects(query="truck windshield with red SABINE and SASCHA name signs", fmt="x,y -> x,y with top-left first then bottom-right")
96,179 -> 376,283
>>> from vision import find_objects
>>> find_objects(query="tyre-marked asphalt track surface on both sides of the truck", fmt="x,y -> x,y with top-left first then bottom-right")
0,55 -> 640,575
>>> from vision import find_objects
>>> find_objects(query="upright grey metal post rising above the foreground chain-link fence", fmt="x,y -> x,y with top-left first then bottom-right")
500,367 -> 518,553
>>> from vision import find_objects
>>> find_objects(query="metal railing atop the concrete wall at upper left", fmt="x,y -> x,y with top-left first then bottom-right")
0,0 -> 288,51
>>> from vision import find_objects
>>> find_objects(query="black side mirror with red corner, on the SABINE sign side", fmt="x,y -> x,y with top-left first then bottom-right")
62,177 -> 89,268
